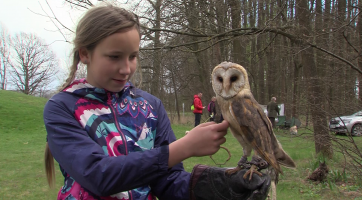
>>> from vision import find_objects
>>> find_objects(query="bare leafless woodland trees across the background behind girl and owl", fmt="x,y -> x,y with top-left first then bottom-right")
0,0 -> 362,181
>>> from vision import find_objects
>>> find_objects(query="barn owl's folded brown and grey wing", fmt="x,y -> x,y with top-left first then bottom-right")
229,96 -> 282,173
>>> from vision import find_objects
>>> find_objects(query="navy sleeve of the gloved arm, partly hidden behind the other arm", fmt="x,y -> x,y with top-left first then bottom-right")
150,100 -> 190,200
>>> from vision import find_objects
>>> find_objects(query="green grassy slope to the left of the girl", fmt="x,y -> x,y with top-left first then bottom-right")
0,90 -> 61,200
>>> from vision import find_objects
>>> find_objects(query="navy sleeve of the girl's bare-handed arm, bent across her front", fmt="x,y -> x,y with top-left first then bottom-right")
44,95 -> 172,196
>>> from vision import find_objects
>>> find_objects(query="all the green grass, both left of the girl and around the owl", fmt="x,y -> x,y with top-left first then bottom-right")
0,90 -> 362,200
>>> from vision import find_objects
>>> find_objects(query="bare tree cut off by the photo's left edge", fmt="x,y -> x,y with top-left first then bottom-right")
0,24 -> 11,90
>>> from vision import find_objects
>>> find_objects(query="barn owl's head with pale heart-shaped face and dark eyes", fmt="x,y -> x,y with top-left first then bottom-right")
212,62 -> 250,99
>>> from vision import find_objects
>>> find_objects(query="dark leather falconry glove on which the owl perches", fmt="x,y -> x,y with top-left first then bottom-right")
189,165 -> 270,200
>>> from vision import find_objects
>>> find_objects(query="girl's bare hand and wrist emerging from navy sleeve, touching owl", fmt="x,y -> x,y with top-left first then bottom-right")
168,120 -> 229,168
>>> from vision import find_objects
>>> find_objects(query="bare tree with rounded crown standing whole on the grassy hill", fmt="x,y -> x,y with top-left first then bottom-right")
9,33 -> 58,95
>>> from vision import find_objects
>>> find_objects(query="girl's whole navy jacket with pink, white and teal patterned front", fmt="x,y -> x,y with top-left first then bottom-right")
44,79 -> 190,200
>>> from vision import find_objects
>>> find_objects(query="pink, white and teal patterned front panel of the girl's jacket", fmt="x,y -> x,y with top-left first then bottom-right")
58,79 -> 157,200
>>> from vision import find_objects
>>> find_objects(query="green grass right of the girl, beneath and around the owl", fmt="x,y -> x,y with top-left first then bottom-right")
177,125 -> 362,200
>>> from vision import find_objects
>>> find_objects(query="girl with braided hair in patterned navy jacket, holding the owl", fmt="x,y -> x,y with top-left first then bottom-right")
44,5 -> 269,200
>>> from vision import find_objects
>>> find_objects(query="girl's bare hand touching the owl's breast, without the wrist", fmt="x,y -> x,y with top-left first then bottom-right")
181,120 -> 229,157
